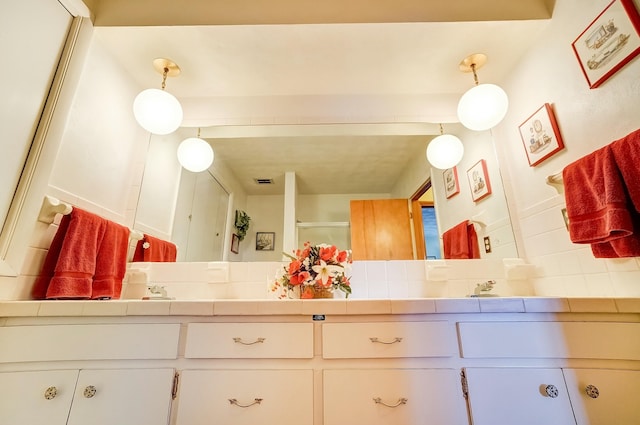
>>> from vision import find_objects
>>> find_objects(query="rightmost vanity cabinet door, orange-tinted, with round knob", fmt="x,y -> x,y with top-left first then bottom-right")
564,369 -> 640,425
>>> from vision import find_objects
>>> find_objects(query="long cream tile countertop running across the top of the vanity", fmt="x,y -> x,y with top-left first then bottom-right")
0,297 -> 640,317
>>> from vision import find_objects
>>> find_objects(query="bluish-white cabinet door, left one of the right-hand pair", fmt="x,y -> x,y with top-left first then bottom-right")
465,368 -> 576,425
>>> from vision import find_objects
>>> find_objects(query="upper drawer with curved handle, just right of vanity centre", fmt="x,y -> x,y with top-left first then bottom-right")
322,321 -> 457,359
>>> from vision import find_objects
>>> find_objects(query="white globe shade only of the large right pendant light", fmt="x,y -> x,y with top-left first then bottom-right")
458,84 -> 509,131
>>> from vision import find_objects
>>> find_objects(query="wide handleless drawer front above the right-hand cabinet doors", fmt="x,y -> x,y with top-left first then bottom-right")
458,322 -> 640,360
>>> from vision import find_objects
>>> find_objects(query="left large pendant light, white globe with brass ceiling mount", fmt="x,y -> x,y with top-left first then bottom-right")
133,58 -> 183,135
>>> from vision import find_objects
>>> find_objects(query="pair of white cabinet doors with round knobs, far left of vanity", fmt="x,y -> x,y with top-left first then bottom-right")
0,369 -> 174,425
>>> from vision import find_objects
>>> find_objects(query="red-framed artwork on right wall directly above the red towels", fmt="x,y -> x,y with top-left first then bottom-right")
519,103 -> 564,167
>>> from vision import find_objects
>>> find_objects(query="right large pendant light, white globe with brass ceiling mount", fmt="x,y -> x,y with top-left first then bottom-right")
458,53 -> 509,131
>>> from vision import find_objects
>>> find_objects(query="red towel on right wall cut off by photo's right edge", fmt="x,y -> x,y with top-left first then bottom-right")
611,126 -> 640,212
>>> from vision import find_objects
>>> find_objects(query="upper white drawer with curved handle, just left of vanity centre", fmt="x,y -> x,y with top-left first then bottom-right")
185,323 -> 313,359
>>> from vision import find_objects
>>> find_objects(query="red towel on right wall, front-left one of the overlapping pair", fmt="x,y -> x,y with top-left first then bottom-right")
562,145 -> 633,244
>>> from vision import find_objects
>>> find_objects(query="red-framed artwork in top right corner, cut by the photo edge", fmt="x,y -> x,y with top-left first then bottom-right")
572,0 -> 640,89
